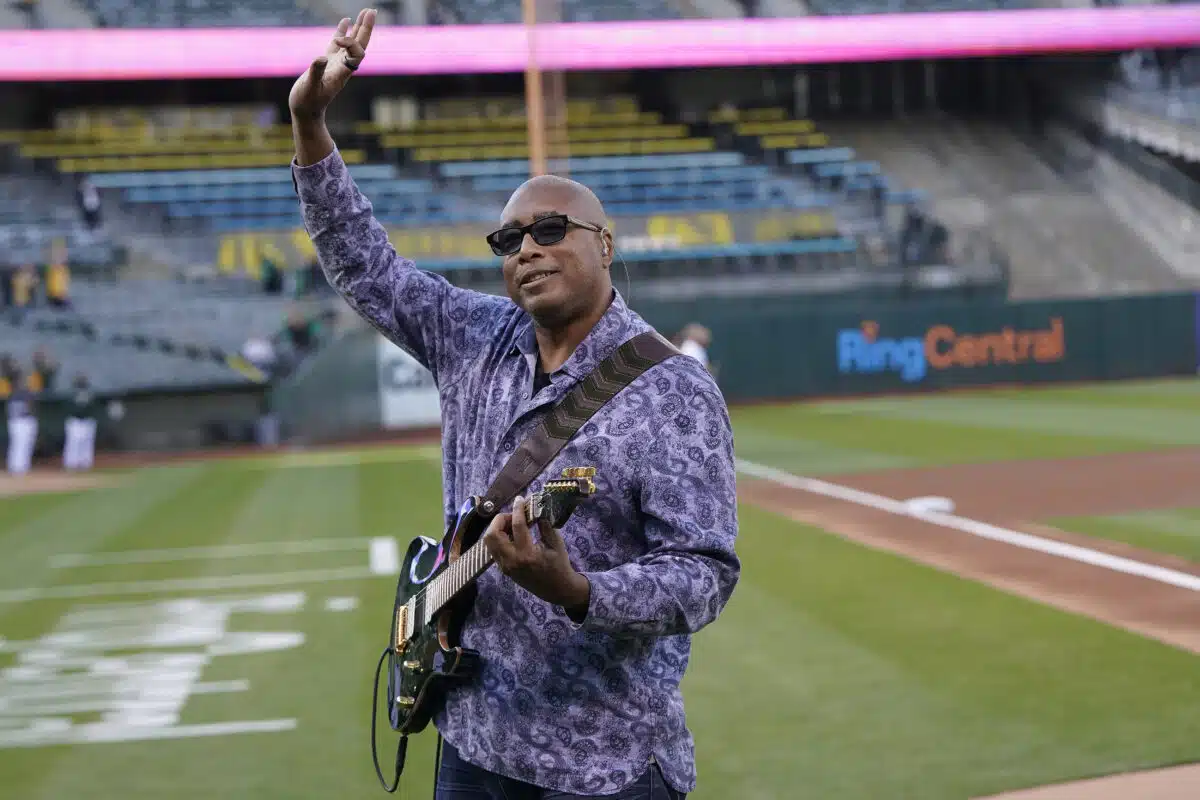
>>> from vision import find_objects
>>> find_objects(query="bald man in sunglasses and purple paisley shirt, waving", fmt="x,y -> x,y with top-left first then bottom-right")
289,11 -> 740,800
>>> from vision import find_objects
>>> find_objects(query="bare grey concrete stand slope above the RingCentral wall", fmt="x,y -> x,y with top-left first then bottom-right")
826,118 -> 1187,297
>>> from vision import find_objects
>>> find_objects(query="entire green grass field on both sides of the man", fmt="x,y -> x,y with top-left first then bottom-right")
0,381 -> 1200,800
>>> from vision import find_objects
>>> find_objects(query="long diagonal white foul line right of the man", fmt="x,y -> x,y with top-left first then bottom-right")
737,458 -> 1200,591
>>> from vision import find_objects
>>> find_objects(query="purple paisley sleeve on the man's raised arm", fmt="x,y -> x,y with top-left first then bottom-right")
292,149 -> 504,386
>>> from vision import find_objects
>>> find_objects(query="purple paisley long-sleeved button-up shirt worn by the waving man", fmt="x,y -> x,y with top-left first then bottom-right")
293,150 -> 740,795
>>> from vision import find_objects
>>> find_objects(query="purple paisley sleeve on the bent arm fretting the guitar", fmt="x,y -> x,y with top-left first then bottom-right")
574,390 -> 742,636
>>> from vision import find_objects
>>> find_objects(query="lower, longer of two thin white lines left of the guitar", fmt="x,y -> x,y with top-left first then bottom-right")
0,566 -> 377,604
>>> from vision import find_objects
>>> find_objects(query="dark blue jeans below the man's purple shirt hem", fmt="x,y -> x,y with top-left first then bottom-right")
434,741 -> 688,800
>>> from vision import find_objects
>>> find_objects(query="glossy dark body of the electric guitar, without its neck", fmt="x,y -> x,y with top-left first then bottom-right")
388,498 -> 491,734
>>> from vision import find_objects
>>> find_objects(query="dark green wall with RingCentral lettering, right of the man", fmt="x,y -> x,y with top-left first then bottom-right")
701,294 -> 1198,402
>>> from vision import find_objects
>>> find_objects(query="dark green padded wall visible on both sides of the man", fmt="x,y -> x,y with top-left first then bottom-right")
267,294 -> 1200,441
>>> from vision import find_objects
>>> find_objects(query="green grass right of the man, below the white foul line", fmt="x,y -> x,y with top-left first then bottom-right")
685,505 -> 1200,800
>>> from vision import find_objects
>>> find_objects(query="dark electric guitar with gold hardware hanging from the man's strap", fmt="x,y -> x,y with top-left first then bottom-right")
371,467 -> 596,792
